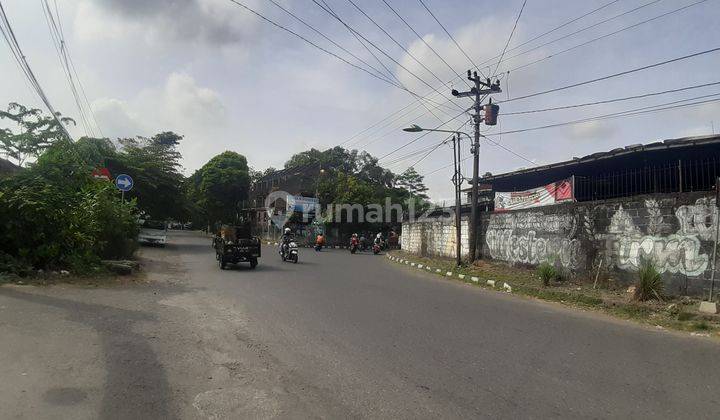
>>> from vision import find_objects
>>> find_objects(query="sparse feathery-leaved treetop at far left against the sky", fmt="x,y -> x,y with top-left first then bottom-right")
0,102 -> 75,166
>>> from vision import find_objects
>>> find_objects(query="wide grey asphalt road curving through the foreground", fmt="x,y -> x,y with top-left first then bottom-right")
0,232 -> 720,419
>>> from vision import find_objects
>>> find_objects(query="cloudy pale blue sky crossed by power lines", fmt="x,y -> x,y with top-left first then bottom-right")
0,0 -> 720,200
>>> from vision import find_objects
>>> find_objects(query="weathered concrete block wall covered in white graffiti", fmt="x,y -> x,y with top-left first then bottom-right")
402,193 -> 720,295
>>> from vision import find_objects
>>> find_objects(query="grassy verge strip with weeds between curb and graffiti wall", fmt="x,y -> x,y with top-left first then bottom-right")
391,251 -> 720,338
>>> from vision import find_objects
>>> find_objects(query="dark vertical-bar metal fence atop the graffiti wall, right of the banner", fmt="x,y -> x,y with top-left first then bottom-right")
575,157 -> 720,201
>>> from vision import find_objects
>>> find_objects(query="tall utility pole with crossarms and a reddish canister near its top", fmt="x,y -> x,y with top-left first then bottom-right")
452,70 -> 502,263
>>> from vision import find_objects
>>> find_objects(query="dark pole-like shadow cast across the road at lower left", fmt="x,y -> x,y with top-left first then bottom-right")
0,287 -> 174,418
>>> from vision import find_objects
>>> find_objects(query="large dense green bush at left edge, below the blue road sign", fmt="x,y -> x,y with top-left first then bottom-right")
0,141 -> 138,274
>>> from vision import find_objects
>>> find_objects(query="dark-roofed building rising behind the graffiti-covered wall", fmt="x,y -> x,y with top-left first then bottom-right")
464,135 -> 720,202
